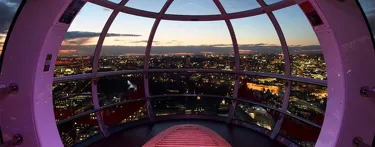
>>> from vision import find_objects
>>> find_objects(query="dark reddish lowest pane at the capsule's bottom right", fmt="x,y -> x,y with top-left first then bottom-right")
279,116 -> 320,147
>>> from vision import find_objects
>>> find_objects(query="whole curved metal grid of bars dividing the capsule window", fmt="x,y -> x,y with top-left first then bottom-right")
53,0 -> 327,145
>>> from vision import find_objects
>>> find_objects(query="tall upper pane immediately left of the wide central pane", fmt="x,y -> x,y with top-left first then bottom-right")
99,13 -> 154,72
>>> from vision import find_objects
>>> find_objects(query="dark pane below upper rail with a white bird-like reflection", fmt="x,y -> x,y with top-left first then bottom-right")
98,74 -> 145,106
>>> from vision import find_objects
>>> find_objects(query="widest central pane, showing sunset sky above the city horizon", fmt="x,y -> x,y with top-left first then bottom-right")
150,21 -> 234,70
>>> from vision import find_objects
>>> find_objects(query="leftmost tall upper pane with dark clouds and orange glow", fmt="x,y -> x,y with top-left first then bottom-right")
55,3 -> 112,76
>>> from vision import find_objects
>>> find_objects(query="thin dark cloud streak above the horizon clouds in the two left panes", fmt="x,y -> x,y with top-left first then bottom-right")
65,31 -> 142,40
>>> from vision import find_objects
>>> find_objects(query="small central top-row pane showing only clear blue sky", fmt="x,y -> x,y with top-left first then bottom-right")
166,0 -> 220,15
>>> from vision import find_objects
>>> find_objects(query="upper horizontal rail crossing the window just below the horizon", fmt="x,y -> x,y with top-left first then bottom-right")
53,69 -> 327,86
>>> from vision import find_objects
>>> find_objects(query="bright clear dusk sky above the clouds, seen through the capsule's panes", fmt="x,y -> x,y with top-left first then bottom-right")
67,0 -> 318,46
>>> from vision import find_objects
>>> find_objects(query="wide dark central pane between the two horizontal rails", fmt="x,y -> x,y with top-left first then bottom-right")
149,73 -> 235,96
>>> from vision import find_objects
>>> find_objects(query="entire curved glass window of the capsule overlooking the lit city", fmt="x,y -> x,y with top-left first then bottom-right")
51,0 -> 328,146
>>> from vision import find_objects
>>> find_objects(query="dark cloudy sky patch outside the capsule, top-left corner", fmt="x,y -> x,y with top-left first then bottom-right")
0,0 -> 21,33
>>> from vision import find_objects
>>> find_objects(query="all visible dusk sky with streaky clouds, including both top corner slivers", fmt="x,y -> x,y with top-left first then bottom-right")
0,0 -> 375,55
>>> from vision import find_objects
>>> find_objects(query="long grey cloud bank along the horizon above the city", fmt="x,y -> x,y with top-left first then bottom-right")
59,43 -> 321,57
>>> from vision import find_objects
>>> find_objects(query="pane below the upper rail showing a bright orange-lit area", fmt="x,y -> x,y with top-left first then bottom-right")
238,76 -> 285,108
